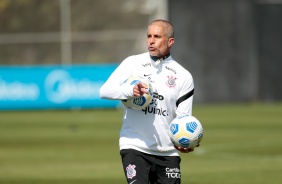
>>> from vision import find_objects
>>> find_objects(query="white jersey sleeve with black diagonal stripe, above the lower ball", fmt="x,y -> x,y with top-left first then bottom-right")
176,73 -> 194,115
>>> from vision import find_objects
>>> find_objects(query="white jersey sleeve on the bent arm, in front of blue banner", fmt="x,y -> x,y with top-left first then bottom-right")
100,57 -> 134,100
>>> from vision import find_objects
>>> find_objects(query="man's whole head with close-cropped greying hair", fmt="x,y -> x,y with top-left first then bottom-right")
147,20 -> 174,57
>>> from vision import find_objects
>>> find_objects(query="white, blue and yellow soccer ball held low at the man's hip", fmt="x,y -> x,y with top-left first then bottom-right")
169,115 -> 204,149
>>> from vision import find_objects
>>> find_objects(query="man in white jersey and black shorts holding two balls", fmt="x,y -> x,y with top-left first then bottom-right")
100,20 -> 194,184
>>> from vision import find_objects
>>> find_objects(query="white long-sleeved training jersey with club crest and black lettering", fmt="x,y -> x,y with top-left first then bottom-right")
100,52 -> 194,156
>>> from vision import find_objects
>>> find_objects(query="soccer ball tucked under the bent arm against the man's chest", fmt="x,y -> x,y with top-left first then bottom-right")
121,76 -> 153,110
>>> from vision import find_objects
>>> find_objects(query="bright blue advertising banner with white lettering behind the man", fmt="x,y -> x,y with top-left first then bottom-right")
0,64 -> 120,110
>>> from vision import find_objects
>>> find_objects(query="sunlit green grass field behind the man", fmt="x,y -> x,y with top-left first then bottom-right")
0,104 -> 282,184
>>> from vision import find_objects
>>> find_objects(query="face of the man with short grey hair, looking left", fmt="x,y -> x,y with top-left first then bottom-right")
147,24 -> 174,57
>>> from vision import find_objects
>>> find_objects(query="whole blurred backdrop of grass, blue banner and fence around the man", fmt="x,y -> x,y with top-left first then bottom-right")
0,0 -> 282,184
